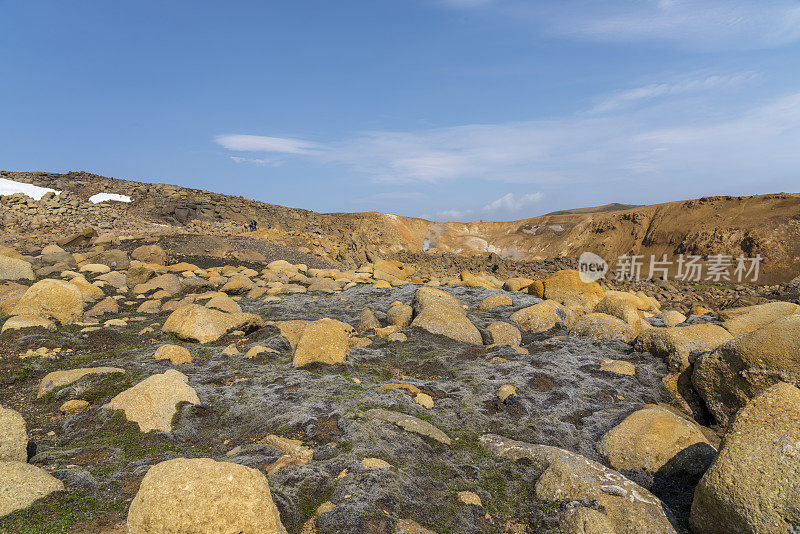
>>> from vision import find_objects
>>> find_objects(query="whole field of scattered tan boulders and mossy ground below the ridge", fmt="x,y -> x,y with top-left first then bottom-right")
0,231 -> 800,534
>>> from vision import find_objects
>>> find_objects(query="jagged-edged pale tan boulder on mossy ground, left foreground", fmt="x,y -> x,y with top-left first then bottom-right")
106,369 -> 200,432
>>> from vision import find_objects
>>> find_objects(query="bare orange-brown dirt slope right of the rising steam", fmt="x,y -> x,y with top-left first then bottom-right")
412,193 -> 800,283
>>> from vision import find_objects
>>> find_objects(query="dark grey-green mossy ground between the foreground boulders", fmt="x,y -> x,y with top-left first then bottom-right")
0,287 -> 680,534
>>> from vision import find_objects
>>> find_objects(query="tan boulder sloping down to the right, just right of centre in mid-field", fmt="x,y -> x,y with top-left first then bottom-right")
411,287 -> 483,345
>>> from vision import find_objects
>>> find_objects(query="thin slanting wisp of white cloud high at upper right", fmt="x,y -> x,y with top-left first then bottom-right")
592,72 -> 758,113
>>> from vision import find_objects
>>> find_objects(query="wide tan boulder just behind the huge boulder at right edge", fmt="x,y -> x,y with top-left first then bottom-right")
635,323 -> 733,371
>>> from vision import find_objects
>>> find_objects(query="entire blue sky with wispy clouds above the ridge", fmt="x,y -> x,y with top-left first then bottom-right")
0,0 -> 800,220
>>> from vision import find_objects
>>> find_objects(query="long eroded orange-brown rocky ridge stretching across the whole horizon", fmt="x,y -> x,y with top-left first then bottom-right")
0,172 -> 800,283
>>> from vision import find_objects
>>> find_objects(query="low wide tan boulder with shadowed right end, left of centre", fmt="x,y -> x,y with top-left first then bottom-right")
161,304 -> 264,343
